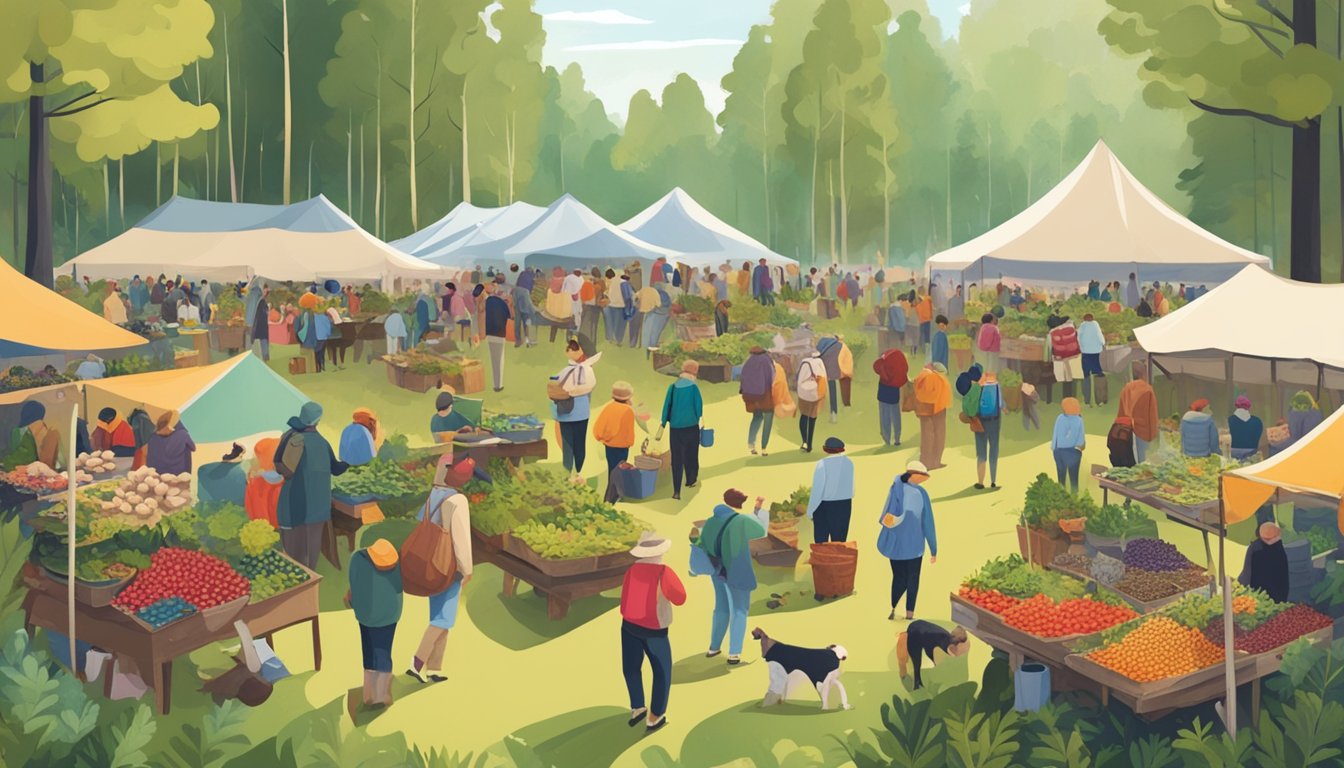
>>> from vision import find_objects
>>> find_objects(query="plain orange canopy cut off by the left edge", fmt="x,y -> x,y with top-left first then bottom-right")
0,260 -> 145,350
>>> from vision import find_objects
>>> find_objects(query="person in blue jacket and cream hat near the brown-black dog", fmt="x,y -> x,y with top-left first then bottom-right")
878,461 -> 938,621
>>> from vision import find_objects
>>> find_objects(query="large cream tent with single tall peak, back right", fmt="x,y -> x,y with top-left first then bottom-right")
926,141 -> 1269,284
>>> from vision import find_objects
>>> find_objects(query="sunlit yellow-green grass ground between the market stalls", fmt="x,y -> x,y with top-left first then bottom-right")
179,313 -> 1245,767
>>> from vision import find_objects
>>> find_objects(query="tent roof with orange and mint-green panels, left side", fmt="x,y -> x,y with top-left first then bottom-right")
85,352 -> 309,444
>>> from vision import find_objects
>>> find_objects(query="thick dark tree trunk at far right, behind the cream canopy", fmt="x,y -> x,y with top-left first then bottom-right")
1289,0 -> 1321,282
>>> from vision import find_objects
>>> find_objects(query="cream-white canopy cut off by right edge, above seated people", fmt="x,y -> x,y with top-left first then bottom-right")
1134,266 -> 1344,389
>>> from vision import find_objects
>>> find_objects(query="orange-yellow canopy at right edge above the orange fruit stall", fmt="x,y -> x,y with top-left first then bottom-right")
1222,409 -> 1344,531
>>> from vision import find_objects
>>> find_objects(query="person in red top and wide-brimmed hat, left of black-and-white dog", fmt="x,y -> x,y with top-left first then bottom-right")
621,533 -> 685,733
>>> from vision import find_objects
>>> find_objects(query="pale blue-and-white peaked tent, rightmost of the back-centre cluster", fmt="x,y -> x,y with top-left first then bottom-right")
621,187 -> 797,268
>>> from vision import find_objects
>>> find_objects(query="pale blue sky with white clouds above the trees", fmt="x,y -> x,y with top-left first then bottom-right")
536,0 -> 968,116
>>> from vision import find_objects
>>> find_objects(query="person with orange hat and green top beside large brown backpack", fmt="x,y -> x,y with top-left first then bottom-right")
345,538 -> 402,718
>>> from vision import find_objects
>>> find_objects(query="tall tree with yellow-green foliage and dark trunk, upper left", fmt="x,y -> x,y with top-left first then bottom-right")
0,0 -> 219,286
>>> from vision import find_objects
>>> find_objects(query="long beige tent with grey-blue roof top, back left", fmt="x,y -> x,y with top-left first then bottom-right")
56,195 -> 442,281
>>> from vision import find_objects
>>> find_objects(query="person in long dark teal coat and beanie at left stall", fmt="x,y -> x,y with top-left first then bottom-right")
274,401 -> 349,569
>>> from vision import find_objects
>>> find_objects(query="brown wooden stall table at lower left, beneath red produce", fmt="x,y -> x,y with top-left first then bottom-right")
23,569 -> 323,714
